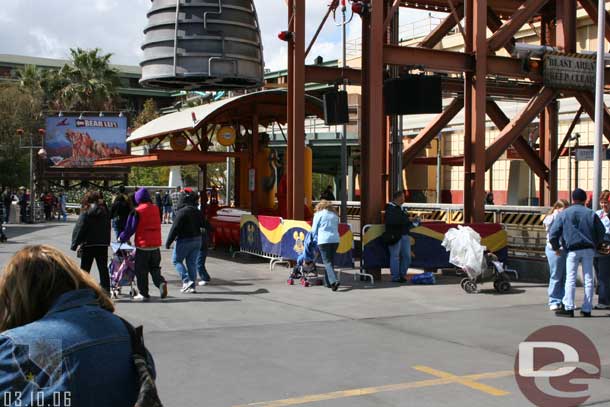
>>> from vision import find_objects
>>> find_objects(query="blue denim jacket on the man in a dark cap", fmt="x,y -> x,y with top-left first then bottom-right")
549,204 -> 606,252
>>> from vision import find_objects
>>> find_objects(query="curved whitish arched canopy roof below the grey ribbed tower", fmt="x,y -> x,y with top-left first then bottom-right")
127,89 -> 323,144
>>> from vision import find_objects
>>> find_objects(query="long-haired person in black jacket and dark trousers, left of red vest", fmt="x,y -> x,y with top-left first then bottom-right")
70,191 -> 110,293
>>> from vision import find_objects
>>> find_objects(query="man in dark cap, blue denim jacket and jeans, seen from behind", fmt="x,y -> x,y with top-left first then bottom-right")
549,188 -> 606,318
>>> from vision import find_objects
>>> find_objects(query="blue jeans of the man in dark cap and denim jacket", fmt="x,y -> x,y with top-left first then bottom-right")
563,249 -> 595,312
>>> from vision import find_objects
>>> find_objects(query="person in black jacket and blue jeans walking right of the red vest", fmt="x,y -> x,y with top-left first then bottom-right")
165,192 -> 203,293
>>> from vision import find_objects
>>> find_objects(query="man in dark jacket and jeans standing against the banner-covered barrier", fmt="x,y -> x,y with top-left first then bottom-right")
383,190 -> 413,283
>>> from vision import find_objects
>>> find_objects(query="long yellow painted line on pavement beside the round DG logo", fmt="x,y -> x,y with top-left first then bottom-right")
233,366 -> 514,407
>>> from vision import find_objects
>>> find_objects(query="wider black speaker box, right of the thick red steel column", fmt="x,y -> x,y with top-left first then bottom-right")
383,75 -> 443,115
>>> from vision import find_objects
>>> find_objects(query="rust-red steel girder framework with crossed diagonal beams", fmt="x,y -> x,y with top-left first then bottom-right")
288,0 -> 610,225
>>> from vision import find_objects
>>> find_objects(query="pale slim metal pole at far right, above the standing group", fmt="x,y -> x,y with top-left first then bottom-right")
591,0 -> 606,210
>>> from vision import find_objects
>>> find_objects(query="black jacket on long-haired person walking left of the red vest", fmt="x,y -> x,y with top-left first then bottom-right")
70,204 -> 110,250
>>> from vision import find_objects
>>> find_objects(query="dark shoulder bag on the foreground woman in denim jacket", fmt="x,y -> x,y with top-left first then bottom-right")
119,317 -> 163,407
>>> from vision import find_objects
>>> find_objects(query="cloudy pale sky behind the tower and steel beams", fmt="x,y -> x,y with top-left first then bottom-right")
0,0 -> 436,70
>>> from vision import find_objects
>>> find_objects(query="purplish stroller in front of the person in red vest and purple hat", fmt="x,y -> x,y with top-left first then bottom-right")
108,243 -> 138,298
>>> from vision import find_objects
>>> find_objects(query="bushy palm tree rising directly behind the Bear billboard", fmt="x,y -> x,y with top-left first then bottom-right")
59,48 -> 119,111
